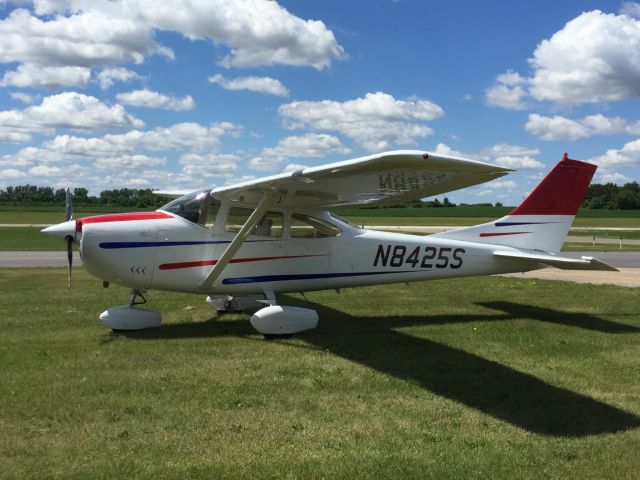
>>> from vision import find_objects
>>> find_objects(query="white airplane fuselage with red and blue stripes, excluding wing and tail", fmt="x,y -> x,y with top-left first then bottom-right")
80,205 -> 531,295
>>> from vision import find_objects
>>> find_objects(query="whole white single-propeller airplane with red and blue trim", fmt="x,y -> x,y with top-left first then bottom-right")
43,151 -> 615,337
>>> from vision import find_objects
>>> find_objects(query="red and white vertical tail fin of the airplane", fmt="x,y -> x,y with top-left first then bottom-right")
434,153 -> 597,253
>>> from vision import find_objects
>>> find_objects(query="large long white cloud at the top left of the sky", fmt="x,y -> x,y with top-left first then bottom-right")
0,0 -> 346,86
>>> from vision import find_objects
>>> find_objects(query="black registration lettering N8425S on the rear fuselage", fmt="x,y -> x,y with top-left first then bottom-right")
373,245 -> 464,269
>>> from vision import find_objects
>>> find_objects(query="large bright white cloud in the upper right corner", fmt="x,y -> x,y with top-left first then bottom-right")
485,9 -> 640,107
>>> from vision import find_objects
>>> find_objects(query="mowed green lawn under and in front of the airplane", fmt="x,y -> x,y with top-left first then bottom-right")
0,269 -> 640,479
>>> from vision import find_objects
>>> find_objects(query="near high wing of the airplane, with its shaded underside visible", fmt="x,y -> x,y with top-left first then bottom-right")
211,150 -> 511,208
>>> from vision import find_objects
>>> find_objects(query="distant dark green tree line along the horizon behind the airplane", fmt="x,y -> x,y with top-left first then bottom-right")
0,182 -> 640,210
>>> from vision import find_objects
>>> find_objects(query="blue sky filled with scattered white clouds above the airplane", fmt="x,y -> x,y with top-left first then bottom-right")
0,0 -> 640,205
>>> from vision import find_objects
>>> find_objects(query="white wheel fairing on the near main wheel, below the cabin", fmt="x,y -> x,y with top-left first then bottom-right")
251,305 -> 318,335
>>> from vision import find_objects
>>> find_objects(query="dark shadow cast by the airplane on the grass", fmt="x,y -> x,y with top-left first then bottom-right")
122,299 -> 640,437
